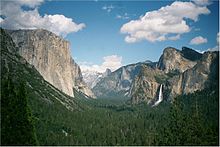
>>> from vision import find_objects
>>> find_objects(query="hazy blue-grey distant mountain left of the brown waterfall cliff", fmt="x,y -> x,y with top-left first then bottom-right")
92,64 -> 144,98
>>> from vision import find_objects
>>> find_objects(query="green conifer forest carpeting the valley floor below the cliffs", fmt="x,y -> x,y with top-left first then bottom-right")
25,86 -> 219,145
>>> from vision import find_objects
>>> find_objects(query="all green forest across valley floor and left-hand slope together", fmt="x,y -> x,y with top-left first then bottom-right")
1,30 -> 219,145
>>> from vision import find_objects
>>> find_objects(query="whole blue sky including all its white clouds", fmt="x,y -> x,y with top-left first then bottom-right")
0,0 -> 219,72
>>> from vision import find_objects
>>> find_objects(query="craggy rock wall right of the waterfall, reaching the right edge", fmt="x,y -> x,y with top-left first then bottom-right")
169,52 -> 219,98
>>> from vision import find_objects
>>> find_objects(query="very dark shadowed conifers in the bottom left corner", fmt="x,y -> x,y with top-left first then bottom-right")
1,77 -> 37,145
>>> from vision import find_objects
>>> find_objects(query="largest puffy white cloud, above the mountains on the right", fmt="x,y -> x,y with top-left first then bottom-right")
120,1 -> 210,43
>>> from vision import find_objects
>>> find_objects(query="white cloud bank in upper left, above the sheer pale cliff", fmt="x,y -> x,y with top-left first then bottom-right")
0,0 -> 85,37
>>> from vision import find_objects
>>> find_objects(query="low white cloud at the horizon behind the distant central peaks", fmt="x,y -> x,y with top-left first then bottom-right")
79,55 -> 122,73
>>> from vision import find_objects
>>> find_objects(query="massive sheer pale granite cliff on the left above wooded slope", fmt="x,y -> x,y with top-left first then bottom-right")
7,29 -> 93,97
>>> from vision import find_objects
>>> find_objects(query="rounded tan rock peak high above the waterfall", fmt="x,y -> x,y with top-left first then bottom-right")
157,47 -> 196,73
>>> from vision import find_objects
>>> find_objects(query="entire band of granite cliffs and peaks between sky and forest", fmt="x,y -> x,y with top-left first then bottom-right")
1,29 -> 219,104
